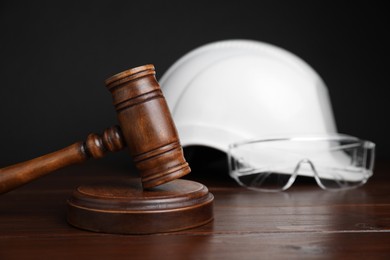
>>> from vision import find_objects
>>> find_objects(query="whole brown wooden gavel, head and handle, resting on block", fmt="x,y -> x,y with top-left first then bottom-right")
0,65 -> 191,194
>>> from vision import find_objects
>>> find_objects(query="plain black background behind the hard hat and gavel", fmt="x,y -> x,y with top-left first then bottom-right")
0,0 -> 390,170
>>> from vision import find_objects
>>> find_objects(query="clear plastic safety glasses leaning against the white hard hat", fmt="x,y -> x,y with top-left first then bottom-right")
228,134 -> 375,191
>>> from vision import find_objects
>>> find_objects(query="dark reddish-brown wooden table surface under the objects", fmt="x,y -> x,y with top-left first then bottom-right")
0,161 -> 390,260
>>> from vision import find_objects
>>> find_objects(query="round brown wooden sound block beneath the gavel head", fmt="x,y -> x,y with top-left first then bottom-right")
67,179 -> 214,234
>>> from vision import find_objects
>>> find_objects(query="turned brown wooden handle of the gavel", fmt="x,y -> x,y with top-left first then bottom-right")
0,126 -> 125,194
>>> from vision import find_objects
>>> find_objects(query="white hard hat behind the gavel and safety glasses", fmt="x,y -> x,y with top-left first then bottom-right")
159,40 -> 337,152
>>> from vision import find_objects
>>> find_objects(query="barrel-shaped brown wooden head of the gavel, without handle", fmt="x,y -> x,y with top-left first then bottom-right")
105,65 -> 191,188
